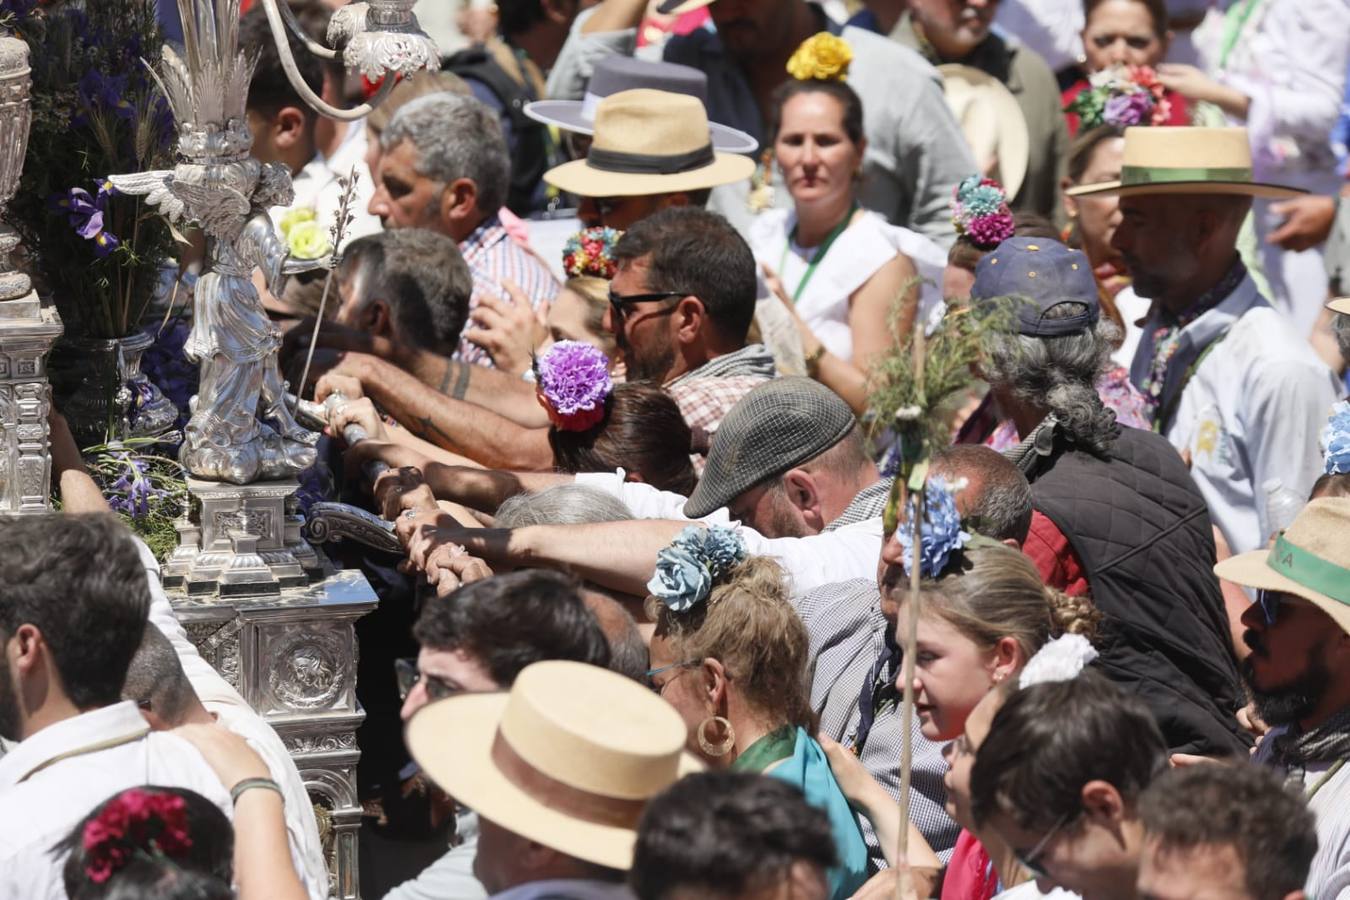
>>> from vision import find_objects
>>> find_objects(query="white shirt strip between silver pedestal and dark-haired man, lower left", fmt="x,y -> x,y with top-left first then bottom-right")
136,538 -> 329,900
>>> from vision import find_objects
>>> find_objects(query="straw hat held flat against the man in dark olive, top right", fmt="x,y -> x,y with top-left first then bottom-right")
937,62 -> 1031,197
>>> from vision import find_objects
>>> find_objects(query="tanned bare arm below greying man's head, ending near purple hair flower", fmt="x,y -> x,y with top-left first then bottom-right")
324,354 -> 554,471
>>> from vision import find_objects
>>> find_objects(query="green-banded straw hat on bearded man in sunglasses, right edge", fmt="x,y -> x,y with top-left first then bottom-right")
1214,497 -> 1350,634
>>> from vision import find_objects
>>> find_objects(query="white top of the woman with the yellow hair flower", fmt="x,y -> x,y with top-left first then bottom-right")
748,209 -> 946,360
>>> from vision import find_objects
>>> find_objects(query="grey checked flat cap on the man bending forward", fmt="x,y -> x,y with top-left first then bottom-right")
684,376 -> 857,518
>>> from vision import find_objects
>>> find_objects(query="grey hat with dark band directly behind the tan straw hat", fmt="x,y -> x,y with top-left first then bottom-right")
525,57 -> 759,152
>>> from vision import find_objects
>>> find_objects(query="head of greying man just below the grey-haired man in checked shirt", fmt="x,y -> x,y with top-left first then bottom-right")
338,228 -> 474,362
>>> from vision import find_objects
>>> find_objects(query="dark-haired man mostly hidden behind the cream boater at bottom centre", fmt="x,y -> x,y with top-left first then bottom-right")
385,569 -> 610,900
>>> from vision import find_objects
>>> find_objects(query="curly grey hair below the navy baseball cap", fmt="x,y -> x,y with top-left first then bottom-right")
981,301 -> 1122,455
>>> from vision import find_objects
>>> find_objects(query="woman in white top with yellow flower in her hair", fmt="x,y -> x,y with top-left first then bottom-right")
749,80 -> 946,413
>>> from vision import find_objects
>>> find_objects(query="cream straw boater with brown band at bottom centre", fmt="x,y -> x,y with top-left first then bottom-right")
406,661 -> 703,869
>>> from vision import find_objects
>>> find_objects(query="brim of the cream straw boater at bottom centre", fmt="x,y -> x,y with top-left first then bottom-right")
405,694 -> 703,870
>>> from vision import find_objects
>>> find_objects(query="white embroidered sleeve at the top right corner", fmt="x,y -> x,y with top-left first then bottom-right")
1223,0 -> 1350,154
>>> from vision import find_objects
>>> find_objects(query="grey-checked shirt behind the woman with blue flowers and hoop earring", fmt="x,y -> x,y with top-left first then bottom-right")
794,577 -> 961,866
